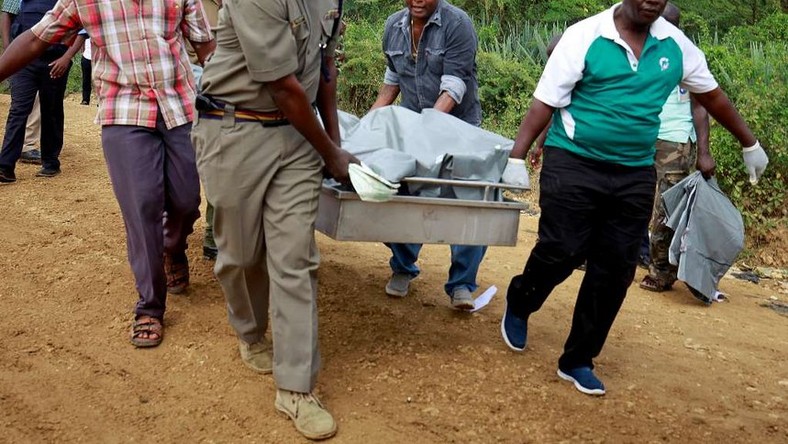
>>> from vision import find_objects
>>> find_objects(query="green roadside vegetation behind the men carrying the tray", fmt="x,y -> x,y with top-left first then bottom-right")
339,0 -> 788,247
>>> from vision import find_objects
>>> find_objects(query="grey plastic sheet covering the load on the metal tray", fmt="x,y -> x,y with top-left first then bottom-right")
339,106 -> 514,200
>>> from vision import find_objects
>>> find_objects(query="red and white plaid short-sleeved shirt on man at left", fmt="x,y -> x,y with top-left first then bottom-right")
32,0 -> 213,128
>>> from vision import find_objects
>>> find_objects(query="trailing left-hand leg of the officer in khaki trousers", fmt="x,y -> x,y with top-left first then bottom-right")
191,119 -> 272,344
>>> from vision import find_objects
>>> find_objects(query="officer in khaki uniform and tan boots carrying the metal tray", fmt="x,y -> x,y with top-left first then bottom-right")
192,0 -> 357,439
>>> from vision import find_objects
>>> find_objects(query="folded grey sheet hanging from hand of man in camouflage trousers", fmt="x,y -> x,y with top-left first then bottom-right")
662,172 -> 744,302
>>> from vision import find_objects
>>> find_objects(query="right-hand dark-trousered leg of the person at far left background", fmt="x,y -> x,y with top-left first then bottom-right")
38,59 -> 71,175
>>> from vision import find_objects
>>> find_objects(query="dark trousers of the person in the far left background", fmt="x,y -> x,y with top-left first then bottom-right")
0,58 -> 71,171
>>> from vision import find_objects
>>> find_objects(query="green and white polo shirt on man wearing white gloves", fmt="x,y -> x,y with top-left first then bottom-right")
534,5 -> 717,166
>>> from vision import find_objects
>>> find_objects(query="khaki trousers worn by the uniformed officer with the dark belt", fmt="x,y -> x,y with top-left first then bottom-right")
192,114 -> 322,392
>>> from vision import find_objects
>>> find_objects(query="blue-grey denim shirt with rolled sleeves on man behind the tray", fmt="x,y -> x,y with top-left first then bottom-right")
383,0 -> 482,126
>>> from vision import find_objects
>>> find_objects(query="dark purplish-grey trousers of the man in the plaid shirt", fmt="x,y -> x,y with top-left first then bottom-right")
101,113 -> 200,319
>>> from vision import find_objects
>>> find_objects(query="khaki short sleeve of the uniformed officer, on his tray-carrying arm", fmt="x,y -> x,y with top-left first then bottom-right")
234,0 -> 298,82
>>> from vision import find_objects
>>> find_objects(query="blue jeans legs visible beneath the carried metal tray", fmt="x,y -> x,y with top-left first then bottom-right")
386,244 -> 487,295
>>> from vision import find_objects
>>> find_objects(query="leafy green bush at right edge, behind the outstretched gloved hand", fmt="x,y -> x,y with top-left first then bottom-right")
704,42 -> 788,246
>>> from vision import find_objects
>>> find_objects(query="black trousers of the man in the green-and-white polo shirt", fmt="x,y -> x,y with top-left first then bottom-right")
506,147 -> 656,370
